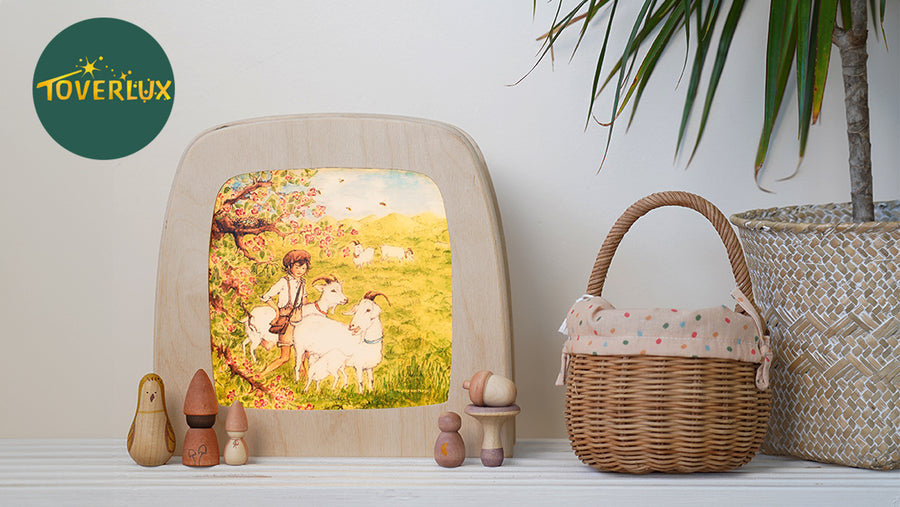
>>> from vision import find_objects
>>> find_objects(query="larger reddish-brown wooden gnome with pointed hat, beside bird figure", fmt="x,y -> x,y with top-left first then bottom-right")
181,369 -> 219,467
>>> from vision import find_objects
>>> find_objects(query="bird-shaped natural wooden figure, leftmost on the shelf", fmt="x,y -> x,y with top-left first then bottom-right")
126,373 -> 175,467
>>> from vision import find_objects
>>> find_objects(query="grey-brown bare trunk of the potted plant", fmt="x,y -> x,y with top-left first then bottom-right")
832,0 -> 875,222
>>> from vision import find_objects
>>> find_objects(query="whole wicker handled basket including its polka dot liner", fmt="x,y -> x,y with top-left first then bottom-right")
557,192 -> 770,474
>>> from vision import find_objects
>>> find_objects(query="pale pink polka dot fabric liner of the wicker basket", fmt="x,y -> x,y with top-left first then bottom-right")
557,289 -> 772,389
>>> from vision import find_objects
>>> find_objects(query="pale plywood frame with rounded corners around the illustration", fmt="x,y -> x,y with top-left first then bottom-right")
154,115 -> 512,456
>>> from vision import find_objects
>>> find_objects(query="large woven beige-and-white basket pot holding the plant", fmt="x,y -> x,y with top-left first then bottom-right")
731,201 -> 900,470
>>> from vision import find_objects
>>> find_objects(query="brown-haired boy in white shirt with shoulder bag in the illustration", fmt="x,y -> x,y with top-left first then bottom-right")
261,250 -> 311,376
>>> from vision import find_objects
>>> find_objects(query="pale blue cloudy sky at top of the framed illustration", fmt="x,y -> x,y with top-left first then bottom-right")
298,169 -> 446,220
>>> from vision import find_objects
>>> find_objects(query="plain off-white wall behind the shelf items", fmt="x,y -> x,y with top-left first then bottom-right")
0,0 -> 900,438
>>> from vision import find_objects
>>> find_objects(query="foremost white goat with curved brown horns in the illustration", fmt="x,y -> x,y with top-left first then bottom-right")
294,291 -> 390,392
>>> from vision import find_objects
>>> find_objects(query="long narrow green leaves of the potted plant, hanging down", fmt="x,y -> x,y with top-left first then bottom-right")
542,0 -> 886,181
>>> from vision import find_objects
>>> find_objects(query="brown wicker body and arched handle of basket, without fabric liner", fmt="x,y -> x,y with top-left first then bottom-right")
564,192 -> 769,474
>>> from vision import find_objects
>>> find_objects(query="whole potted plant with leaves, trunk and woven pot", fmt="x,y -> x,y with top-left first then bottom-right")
541,0 -> 900,469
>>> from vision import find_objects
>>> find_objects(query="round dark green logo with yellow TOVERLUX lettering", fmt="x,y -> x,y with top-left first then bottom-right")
32,18 -> 175,160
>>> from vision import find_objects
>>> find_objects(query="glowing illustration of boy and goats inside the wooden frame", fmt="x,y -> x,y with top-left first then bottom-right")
209,168 -> 452,410
